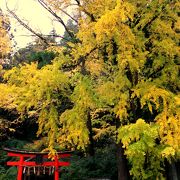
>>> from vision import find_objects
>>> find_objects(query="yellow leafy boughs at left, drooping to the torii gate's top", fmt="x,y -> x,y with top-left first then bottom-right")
0,61 -> 68,152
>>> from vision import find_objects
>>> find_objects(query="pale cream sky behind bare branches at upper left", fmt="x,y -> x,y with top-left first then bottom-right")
0,0 -> 64,47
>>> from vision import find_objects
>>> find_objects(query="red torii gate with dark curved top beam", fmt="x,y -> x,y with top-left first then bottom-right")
4,148 -> 71,180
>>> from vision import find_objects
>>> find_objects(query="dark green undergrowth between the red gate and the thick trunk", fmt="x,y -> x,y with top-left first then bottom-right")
61,147 -> 117,180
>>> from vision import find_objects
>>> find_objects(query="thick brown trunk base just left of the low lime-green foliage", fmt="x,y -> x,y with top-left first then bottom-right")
116,142 -> 129,180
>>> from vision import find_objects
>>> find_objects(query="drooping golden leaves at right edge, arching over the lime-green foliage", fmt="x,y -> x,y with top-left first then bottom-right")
134,84 -> 180,151
